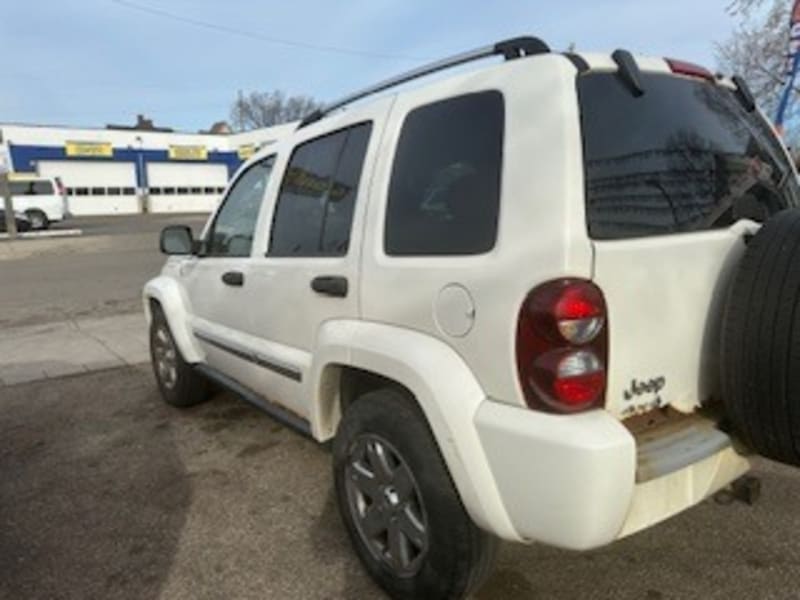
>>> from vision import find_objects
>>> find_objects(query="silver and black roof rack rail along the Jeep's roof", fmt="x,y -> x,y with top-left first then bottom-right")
298,36 -> 550,129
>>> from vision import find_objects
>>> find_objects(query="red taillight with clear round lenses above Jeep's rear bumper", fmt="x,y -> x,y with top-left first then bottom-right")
517,279 -> 608,413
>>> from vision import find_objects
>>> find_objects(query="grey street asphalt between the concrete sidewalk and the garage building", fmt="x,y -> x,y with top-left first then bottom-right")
0,215 -> 207,327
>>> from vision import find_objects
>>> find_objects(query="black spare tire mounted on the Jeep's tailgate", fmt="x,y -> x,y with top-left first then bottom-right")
721,209 -> 800,466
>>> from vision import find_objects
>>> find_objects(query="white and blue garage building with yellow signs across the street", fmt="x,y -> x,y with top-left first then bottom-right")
0,116 -> 296,215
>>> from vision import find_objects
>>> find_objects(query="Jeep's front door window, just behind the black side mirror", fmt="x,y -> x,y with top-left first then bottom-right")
206,156 -> 275,257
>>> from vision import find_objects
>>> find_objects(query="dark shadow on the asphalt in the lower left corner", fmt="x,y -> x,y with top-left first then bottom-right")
0,369 -> 192,599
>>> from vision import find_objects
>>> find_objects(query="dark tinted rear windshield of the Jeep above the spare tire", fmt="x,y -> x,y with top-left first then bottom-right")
578,73 -> 800,239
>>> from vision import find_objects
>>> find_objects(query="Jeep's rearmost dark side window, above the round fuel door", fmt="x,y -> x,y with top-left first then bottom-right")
384,91 -> 505,256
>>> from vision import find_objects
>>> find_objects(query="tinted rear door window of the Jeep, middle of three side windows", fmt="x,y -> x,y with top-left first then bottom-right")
269,123 -> 372,256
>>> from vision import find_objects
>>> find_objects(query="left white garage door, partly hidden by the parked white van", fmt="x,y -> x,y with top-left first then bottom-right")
38,160 -> 139,215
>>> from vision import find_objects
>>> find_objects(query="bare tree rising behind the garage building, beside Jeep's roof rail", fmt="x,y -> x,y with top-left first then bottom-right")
231,90 -> 322,131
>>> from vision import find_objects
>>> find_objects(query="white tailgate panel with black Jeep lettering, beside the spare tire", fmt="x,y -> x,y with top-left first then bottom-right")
594,221 -> 758,418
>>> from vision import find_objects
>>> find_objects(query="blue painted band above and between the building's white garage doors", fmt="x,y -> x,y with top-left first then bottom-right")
8,143 -> 243,187
